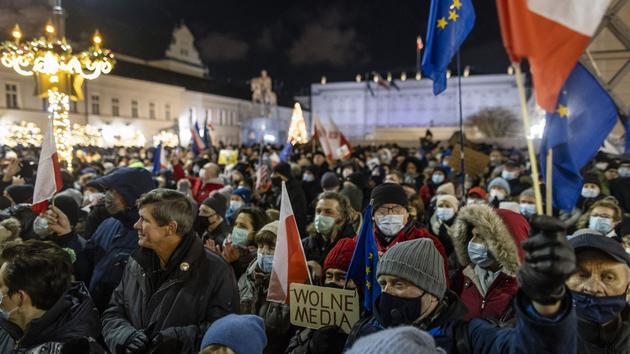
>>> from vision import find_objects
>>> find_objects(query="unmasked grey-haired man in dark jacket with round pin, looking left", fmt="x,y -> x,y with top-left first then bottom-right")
103,189 -> 239,353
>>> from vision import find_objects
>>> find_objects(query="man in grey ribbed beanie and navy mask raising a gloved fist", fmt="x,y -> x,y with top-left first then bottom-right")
346,216 -> 577,353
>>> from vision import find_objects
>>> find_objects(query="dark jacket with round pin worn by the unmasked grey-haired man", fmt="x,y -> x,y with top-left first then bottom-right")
103,233 -> 239,353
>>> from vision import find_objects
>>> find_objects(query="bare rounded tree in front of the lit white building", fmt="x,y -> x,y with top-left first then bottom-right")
466,107 -> 519,138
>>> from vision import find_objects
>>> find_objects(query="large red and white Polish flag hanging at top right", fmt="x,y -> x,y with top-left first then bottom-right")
497,0 -> 610,112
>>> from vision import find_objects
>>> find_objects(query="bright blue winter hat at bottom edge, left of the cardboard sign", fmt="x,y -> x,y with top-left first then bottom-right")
200,314 -> 267,354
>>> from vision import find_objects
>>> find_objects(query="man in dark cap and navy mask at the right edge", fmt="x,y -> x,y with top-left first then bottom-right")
567,229 -> 630,354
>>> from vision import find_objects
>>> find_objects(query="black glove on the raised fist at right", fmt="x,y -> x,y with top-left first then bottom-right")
517,215 -> 575,305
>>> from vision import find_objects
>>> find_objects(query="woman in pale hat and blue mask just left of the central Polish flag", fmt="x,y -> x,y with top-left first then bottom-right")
238,221 -> 291,354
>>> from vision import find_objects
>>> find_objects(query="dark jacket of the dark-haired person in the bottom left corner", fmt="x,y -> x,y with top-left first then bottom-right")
0,283 -> 105,354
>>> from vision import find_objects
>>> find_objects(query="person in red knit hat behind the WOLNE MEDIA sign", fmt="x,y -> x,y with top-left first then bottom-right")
285,238 -> 356,354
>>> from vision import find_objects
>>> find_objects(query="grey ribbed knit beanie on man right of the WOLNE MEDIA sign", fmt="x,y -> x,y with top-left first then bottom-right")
376,238 -> 446,299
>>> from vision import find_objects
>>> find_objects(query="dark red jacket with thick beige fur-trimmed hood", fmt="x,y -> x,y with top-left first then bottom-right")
450,205 -> 529,320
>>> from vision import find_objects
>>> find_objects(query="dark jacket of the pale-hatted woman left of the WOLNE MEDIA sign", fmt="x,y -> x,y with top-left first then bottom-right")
238,259 -> 291,354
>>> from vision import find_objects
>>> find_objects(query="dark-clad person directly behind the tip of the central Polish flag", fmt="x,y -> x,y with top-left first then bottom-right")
271,162 -> 307,237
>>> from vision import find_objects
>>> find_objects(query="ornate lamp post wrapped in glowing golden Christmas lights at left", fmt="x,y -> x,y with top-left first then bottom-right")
0,0 -> 116,169
